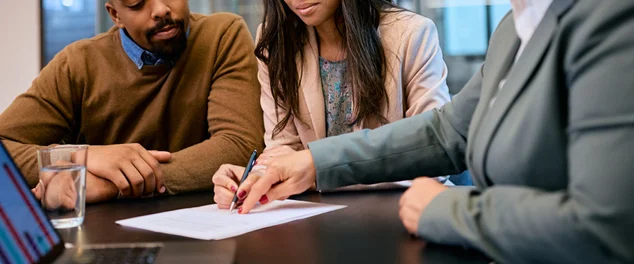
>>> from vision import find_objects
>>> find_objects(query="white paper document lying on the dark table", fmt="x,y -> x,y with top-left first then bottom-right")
116,200 -> 346,240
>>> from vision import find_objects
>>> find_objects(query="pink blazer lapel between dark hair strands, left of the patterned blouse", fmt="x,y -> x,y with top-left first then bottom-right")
299,27 -> 326,140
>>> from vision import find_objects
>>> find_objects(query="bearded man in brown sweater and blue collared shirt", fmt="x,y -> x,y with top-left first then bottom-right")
0,0 -> 263,202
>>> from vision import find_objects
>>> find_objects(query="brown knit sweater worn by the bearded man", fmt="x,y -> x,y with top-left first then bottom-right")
0,13 -> 264,193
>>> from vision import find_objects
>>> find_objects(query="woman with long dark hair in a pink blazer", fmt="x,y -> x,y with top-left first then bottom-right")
210,0 -> 449,206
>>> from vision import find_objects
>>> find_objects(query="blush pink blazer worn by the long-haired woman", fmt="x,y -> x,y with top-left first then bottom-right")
256,11 -> 450,150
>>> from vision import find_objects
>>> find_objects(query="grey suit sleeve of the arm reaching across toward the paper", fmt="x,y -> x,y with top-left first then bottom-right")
308,62 -> 484,190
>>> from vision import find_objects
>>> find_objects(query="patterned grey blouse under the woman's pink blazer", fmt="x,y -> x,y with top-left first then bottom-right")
319,57 -> 354,137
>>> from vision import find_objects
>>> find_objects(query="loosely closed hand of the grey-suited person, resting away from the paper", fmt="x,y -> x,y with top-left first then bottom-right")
398,177 -> 447,235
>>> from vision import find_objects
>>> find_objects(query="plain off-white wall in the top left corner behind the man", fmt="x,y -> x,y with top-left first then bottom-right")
0,0 -> 41,112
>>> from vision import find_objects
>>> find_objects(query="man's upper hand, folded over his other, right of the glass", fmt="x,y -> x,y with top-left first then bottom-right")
86,144 -> 172,197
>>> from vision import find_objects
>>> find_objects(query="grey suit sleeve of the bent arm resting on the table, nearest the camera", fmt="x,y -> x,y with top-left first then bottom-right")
418,2 -> 634,263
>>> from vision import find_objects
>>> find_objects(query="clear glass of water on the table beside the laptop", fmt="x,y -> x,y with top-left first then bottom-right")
37,145 -> 88,228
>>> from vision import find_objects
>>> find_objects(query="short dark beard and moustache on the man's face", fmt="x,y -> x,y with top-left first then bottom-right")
145,17 -> 187,61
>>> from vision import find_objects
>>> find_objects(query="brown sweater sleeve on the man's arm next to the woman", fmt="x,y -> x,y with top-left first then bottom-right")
162,18 -> 263,194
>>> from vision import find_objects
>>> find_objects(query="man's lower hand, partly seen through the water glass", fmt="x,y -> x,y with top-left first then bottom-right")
31,172 -> 119,206
